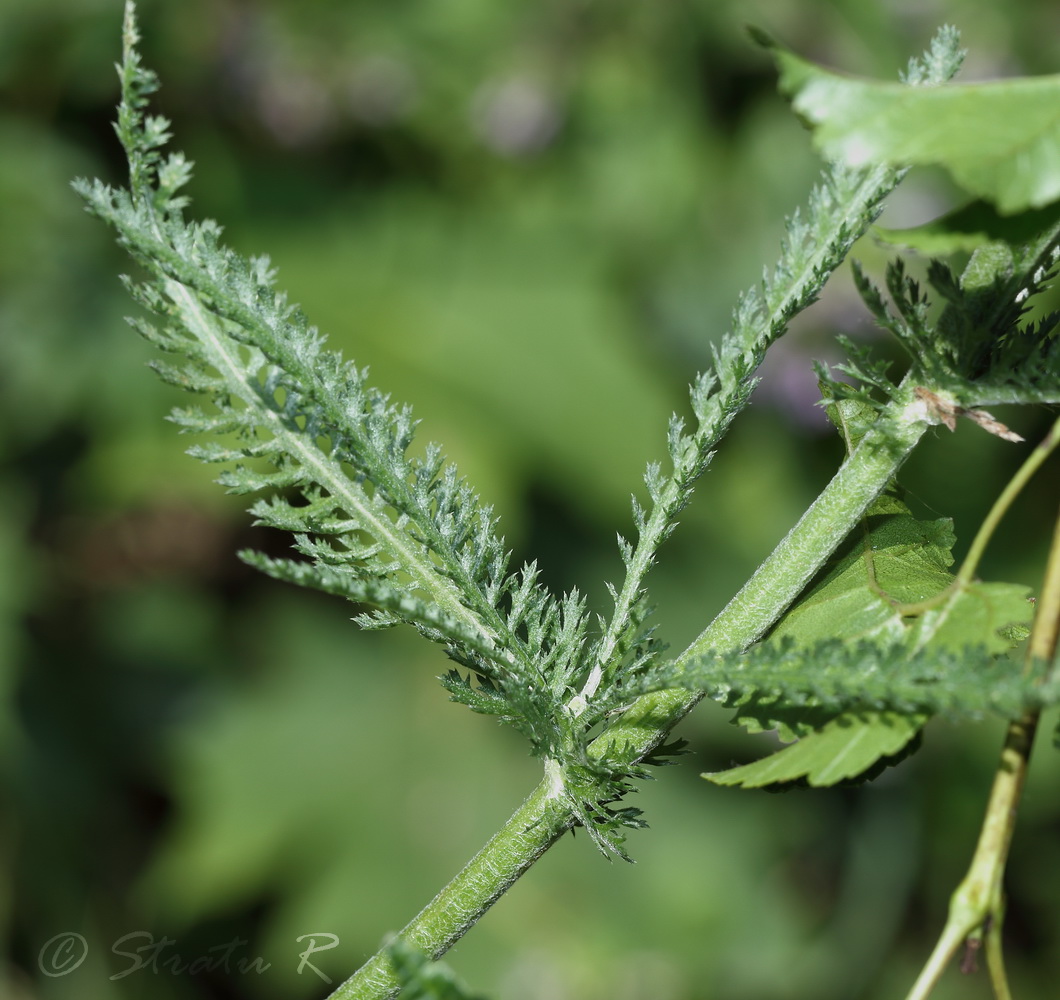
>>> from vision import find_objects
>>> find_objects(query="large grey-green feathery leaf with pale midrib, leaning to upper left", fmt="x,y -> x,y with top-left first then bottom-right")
76,4 -> 614,776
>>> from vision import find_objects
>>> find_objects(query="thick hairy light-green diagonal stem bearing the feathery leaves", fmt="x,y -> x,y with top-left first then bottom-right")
329,391 -> 928,1000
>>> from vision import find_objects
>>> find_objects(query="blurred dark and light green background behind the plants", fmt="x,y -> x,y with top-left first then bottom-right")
6,0 -> 1060,1000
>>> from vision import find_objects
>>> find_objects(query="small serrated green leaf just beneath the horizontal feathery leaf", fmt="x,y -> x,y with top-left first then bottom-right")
703,712 -> 926,788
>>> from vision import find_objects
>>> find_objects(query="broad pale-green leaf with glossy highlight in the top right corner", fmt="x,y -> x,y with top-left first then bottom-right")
769,35 -> 1060,214
